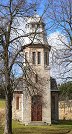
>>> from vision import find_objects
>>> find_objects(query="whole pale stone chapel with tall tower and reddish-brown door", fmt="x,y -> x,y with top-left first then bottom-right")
12,14 -> 58,125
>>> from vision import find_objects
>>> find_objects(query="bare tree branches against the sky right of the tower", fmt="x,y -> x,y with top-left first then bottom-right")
46,0 -> 72,80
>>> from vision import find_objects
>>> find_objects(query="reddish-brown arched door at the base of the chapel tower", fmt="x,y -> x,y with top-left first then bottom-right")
31,95 -> 42,121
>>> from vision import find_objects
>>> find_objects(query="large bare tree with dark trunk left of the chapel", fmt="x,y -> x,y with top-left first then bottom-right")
0,0 -> 43,134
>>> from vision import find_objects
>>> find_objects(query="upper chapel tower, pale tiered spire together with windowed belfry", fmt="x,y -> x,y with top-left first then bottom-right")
24,14 -> 50,69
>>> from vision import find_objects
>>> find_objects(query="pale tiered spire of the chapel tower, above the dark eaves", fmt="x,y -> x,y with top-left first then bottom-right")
26,14 -> 48,45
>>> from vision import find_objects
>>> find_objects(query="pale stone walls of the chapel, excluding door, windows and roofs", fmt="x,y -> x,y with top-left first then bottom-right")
13,45 -> 58,125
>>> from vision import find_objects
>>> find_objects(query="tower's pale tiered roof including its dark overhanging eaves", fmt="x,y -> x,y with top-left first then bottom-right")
24,13 -> 50,50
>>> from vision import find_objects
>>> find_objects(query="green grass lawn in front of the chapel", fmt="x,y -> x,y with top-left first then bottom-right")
0,100 -> 72,134
